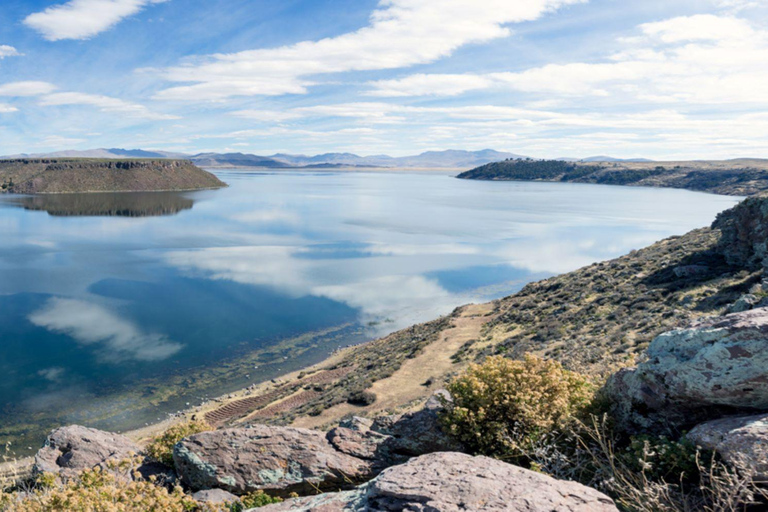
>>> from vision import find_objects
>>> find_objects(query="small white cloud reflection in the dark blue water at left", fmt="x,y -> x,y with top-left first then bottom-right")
29,298 -> 183,362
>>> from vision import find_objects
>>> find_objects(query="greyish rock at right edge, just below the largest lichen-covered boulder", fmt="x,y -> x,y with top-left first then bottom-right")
686,413 -> 768,482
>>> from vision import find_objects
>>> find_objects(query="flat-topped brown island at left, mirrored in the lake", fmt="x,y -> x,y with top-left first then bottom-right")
0,158 -> 225,194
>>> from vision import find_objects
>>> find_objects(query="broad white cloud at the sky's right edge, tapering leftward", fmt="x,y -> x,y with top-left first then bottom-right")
369,14 -> 768,106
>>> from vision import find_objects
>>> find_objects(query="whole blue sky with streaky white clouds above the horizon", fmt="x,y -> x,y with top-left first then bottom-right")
0,0 -> 768,160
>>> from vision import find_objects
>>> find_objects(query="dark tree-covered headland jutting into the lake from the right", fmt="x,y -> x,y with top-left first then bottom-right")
458,159 -> 768,196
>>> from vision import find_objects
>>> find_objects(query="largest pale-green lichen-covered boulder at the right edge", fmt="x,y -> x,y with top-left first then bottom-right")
606,308 -> 768,430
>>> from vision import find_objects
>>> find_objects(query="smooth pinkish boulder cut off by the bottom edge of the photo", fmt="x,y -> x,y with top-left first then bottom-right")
255,452 -> 618,512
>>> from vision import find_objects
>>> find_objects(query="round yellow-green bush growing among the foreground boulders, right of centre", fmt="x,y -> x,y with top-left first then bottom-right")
442,355 -> 594,459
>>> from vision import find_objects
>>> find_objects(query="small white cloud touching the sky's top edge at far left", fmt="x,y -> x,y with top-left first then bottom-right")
24,0 -> 166,41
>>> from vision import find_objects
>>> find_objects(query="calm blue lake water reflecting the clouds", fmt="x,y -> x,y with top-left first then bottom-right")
0,171 -> 738,453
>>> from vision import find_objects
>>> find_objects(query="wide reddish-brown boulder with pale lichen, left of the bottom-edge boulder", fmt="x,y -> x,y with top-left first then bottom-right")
173,425 -> 371,495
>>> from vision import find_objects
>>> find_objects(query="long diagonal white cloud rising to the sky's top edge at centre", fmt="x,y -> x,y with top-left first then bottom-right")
157,0 -> 583,100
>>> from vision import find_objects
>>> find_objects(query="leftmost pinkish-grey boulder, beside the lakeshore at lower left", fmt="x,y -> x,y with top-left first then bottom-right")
34,425 -> 141,480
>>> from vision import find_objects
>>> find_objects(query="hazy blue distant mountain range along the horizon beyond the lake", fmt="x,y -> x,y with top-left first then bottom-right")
0,148 -> 650,169
